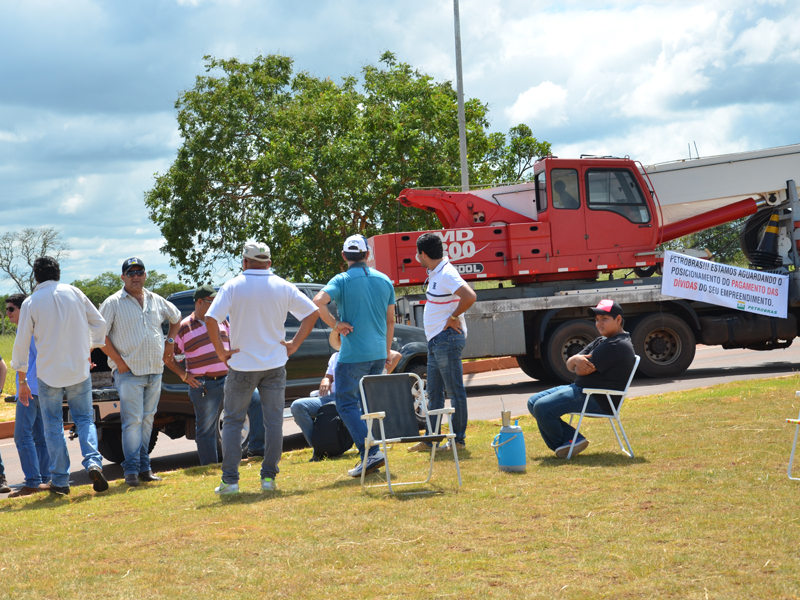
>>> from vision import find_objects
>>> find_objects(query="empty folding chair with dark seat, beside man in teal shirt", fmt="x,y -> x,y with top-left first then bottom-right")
359,373 -> 461,494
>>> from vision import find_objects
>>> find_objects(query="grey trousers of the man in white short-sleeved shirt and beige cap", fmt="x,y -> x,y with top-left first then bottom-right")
222,367 -> 286,483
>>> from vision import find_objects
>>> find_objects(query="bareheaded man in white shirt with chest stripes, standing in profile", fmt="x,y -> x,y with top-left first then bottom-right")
409,233 -> 476,452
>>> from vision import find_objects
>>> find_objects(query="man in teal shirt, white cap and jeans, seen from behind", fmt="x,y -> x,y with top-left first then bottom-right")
314,235 -> 395,477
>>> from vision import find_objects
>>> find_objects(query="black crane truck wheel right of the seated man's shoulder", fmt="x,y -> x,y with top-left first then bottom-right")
631,313 -> 697,377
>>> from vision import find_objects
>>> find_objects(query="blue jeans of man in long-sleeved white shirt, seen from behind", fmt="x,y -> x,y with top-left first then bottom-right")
37,377 -> 103,487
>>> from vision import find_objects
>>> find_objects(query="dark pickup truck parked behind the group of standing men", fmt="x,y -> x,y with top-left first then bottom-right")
79,283 -> 428,463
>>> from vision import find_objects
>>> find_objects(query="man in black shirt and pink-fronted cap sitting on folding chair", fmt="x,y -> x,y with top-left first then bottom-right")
528,300 -> 636,458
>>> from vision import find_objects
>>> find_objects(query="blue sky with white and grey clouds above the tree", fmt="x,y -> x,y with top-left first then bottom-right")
0,0 -> 800,291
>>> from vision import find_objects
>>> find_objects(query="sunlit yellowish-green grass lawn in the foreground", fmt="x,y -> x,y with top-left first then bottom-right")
0,376 -> 800,600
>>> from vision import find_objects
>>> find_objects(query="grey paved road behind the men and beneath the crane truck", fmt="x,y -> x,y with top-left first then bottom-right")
0,343 -> 800,498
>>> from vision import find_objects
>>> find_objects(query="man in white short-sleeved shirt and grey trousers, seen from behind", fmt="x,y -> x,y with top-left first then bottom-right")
206,242 -> 318,494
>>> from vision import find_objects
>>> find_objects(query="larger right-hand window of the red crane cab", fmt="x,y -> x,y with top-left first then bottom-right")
586,169 -> 650,223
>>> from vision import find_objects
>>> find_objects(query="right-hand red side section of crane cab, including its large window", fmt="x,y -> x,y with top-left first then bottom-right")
583,167 -> 657,252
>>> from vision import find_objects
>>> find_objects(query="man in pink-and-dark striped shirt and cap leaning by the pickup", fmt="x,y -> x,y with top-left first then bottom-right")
167,285 -> 228,465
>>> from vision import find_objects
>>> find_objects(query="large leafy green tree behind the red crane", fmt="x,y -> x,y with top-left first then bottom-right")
145,52 -> 550,281
